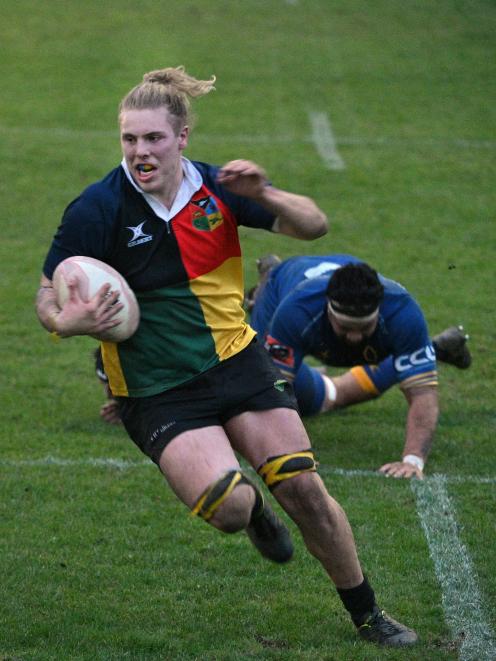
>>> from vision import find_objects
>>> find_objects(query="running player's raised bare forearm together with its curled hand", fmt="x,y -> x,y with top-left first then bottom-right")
218,160 -> 327,240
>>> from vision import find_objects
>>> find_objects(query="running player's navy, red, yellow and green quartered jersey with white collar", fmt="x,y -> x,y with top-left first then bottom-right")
43,159 -> 275,397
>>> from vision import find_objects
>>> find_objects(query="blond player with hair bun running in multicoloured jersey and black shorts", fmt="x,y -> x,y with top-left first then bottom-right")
37,67 -> 417,646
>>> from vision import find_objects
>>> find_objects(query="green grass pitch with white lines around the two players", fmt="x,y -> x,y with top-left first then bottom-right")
0,0 -> 496,661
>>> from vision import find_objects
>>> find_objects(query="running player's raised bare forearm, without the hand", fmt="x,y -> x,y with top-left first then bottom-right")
257,186 -> 327,240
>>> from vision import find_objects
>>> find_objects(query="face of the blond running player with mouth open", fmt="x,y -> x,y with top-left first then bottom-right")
120,108 -> 188,202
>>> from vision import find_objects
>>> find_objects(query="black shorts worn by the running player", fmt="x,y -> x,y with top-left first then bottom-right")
118,342 -> 298,464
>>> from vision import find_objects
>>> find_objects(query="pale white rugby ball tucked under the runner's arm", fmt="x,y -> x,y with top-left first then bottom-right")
52,255 -> 140,342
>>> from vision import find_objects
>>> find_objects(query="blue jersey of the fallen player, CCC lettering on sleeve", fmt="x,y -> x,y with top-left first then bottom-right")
250,254 -> 437,415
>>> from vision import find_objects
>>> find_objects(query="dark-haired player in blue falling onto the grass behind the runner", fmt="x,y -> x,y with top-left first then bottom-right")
248,254 -> 471,478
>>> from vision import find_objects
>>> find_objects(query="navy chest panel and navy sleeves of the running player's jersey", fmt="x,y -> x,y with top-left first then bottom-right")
43,161 -> 275,291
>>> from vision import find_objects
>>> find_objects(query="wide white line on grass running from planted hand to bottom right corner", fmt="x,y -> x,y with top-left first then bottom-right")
411,475 -> 496,661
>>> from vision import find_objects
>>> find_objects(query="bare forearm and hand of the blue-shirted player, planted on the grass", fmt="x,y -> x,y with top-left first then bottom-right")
379,386 -> 439,478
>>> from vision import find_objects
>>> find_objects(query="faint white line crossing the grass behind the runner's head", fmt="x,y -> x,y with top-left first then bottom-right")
0,125 -> 496,150
